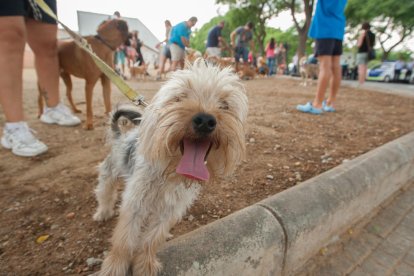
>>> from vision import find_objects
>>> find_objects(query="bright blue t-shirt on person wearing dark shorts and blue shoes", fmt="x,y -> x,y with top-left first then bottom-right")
308,0 -> 347,40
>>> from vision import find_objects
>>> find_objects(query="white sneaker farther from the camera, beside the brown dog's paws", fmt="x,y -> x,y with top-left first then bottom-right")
40,103 -> 81,126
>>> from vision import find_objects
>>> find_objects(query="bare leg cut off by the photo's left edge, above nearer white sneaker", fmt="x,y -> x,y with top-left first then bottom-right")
0,16 -> 26,123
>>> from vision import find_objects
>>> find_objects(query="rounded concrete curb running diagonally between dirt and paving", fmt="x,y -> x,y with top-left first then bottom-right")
158,132 -> 414,276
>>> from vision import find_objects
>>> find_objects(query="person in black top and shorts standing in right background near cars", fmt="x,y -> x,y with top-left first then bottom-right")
356,22 -> 375,85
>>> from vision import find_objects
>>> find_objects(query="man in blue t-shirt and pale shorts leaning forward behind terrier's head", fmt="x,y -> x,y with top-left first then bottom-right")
169,16 -> 197,71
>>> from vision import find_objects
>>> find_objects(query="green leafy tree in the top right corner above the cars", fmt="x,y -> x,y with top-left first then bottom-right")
345,0 -> 414,59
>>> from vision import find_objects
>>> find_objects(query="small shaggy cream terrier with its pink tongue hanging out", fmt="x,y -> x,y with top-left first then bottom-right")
94,59 -> 248,276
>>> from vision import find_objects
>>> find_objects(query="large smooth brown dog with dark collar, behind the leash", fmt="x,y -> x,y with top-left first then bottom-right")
39,19 -> 128,129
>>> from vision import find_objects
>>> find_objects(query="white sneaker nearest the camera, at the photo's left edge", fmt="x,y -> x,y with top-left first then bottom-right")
1,123 -> 47,157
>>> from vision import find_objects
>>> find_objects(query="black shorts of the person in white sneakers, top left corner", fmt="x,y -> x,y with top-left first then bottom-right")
0,0 -> 57,24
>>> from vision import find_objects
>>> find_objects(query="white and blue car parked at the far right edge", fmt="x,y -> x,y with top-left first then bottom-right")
367,61 -> 414,83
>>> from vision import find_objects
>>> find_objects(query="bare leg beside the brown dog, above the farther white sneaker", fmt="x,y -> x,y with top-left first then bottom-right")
26,19 -> 59,107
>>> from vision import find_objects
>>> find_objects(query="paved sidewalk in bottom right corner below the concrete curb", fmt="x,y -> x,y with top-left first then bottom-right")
297,183 -> 414,276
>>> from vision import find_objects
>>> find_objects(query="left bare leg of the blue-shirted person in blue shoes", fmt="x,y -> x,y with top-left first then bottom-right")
312,56 -> 332,108
